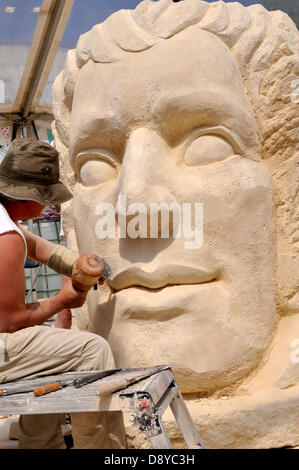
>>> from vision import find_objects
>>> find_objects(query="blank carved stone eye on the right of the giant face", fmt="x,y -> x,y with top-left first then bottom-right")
184,134 -> 235,166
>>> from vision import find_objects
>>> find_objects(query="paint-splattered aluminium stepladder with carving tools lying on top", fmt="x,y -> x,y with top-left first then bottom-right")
0,368 -> 204,449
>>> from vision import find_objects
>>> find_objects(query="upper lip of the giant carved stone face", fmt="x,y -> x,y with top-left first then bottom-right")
109,264 -> 218,291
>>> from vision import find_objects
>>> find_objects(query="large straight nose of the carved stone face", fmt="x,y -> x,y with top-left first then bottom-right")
116,128 -> 176,236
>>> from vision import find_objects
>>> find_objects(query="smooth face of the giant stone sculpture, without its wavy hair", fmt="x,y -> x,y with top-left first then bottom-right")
52,2 -> 298,393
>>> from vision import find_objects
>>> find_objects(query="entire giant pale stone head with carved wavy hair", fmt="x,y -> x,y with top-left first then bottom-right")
53,0 -> 299,447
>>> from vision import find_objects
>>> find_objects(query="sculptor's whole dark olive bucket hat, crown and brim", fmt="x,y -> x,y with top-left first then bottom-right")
0,138 -> 72,205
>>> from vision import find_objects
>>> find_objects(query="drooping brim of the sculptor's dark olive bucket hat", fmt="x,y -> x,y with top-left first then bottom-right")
0,175 -> 73,205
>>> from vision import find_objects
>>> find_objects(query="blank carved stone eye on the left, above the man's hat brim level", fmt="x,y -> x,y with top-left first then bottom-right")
78,150 -> 117,186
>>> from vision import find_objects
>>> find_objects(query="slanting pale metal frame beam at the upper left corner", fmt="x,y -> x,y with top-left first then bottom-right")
0,0 -> 74,127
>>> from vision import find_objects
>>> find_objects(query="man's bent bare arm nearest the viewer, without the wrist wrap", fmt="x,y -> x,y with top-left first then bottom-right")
0,232 -> 86,333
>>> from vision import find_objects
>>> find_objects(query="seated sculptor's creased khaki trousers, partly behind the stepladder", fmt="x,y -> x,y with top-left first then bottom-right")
0,326 -> 126,449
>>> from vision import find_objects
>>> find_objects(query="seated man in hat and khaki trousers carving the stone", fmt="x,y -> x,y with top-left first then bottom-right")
0,138 -> 125,449
